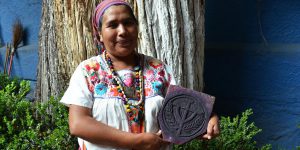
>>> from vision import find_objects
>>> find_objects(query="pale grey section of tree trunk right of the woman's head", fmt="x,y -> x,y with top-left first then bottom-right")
137,0 -> 204,91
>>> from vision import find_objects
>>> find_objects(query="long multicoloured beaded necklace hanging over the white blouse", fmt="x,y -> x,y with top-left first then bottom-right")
103,51 -> 144,133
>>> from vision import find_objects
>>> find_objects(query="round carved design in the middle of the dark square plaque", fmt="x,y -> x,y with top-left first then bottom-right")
162,95 -> 206,137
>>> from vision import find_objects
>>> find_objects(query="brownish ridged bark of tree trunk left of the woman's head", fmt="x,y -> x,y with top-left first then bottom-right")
36,0 -> 98,101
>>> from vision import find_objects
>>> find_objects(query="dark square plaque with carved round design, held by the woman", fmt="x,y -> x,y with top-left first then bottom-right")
158,85 -> 215,144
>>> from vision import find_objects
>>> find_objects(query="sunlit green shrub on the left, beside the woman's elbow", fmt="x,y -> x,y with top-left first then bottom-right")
0,76 -> 77,150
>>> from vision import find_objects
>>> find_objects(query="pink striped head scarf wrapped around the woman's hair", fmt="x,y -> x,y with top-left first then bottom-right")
92,0 -> 130,51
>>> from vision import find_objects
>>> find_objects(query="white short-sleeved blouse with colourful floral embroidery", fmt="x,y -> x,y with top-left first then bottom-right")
60,55 -> 175,150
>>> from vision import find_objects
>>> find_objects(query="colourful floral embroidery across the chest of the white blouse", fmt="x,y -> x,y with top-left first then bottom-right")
83,56 -> 172,97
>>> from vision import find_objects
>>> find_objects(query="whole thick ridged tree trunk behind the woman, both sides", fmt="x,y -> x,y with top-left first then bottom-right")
36,0 -> 204,101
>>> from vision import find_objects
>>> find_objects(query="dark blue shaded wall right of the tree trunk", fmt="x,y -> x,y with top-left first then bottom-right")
204,0 -> 300,149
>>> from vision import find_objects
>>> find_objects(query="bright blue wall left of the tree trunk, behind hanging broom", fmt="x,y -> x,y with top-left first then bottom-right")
0,0 -> 42,97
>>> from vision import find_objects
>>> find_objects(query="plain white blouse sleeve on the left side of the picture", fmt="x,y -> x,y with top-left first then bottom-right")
60,64 -> 93,108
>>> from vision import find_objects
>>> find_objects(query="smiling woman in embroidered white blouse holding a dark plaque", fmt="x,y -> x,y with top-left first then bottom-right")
61,0 -> 219,150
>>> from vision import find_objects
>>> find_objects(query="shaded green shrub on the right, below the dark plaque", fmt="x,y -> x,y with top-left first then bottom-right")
175,109 -> 272,150
